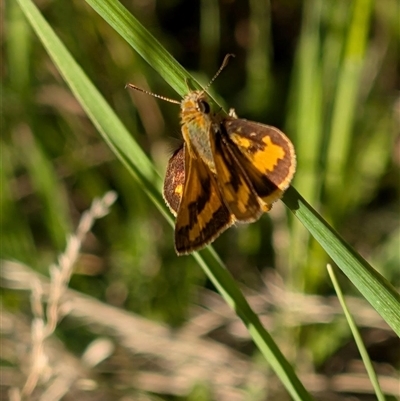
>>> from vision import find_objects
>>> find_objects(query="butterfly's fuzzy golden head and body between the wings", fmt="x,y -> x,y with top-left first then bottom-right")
181,91 -> 220,172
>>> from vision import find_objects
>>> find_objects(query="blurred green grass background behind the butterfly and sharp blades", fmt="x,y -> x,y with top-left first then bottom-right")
0,0 -> 400,400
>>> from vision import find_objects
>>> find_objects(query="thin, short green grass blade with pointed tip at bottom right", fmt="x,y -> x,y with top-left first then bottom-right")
327,265 -> 385,401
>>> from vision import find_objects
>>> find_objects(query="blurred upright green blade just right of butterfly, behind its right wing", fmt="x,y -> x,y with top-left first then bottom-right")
287,0 -> 324,291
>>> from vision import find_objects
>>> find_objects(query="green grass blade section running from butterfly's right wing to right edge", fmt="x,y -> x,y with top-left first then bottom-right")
283,187 -> 400,336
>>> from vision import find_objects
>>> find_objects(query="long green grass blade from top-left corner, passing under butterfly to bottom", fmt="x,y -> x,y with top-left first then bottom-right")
18,0 -> 312,400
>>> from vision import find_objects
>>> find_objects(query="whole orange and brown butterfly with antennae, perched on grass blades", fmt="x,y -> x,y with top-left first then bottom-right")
128,55 -> 296,255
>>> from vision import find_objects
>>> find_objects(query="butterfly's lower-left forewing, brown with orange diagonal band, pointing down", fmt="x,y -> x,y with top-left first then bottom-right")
175,146 -> 234,254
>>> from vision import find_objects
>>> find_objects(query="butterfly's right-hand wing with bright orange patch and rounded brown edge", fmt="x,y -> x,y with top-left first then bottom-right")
221,117 -> 296,205
